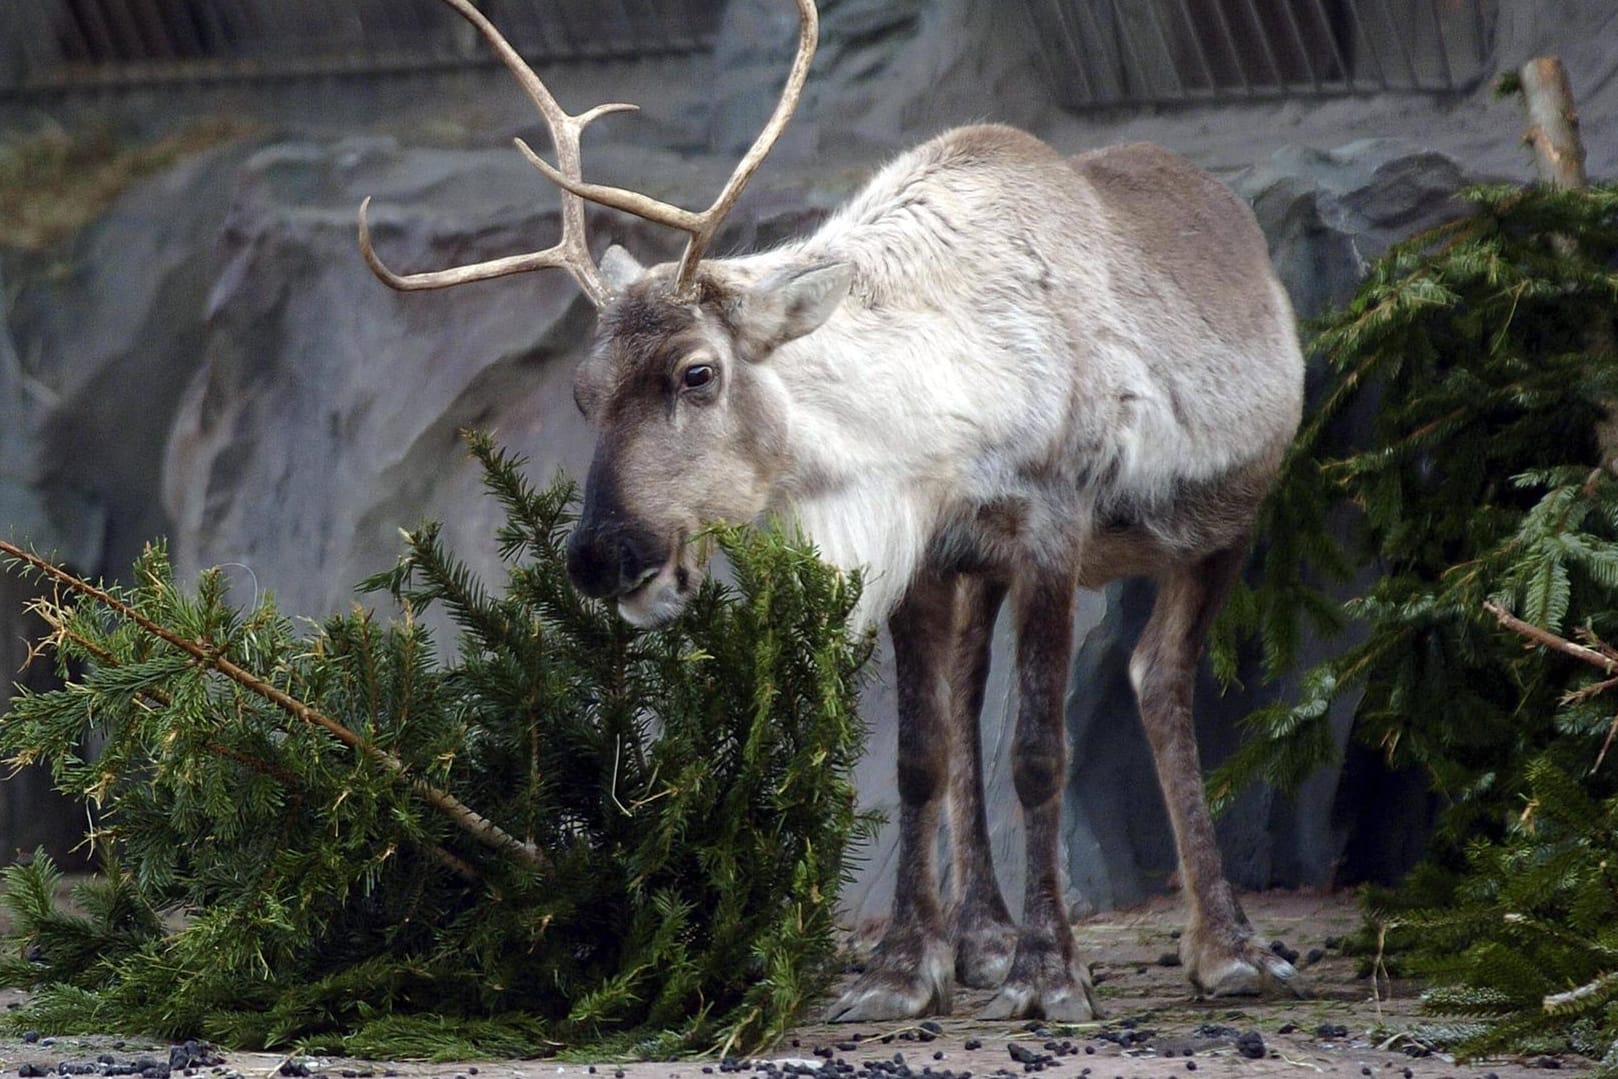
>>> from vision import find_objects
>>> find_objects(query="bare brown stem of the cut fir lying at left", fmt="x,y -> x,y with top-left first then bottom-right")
0,540 -> 550,869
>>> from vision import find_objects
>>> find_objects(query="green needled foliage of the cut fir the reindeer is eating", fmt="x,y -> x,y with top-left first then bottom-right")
0,437 -> 870,1058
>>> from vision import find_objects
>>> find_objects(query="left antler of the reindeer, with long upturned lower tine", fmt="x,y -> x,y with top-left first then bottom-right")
359,0 -> 636,307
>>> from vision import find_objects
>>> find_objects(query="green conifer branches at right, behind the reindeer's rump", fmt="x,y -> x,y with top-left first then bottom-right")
1210,179 -> 1618,1056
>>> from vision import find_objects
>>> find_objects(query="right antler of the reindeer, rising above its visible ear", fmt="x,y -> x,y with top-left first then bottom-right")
520,0 -> 820,294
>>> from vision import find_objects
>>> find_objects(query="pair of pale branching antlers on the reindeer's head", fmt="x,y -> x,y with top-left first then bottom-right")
359,0 -> 820,307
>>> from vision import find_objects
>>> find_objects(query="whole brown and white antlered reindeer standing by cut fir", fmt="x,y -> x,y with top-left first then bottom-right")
359,0 -> 1302,1021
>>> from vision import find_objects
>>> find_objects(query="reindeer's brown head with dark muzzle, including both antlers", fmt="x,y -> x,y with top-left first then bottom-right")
359,0 -> 849,626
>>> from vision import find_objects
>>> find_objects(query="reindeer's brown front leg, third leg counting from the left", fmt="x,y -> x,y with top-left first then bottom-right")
984,566 -> 1097,1022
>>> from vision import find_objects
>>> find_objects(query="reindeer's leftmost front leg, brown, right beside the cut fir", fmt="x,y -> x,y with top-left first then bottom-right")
828,574 -> 955,1022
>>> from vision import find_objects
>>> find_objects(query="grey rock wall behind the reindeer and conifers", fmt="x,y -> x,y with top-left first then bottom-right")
0,0 -> 1618,920
